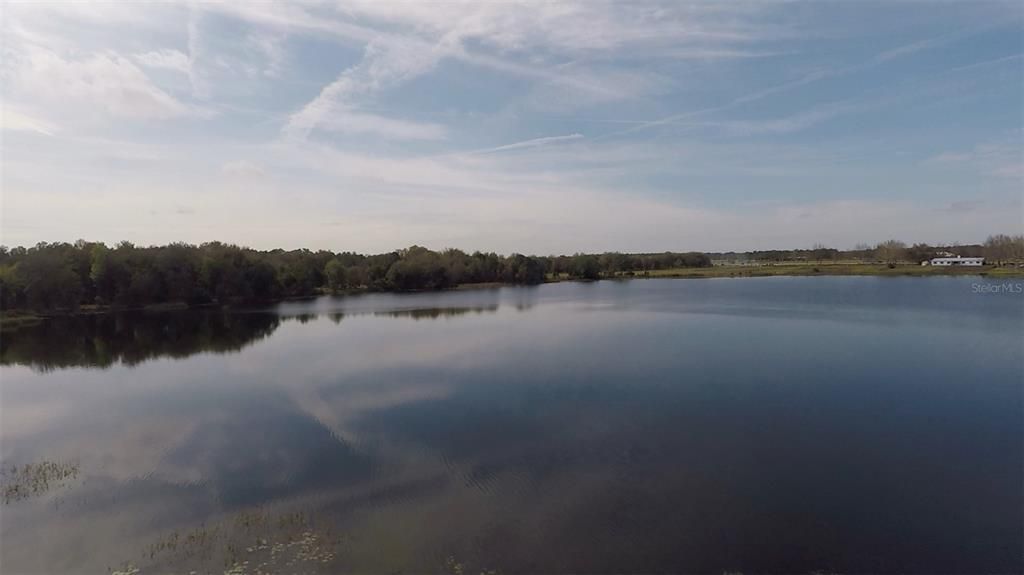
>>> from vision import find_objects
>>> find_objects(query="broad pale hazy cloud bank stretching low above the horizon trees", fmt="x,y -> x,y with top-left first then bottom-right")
4,127 -> 1020,254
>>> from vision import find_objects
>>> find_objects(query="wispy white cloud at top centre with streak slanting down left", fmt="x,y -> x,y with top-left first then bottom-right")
278,2 -> 777,137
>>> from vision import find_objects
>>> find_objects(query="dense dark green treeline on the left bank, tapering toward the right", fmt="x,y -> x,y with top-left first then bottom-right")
0,240 -> 711,311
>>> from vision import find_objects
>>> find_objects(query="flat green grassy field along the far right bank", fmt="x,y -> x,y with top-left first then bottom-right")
610,262 -> 1024,277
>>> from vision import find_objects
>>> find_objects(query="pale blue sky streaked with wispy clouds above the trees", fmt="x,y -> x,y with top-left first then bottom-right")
0,0 -> 1024,254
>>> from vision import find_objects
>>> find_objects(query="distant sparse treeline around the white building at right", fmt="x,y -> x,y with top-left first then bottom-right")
709,234 -> 1024,265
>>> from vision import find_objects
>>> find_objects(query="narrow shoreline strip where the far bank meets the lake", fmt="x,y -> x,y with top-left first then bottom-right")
0,263 -> 1024,328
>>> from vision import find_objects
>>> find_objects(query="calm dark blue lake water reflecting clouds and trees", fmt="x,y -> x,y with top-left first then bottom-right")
0,277 -> 1024,575
